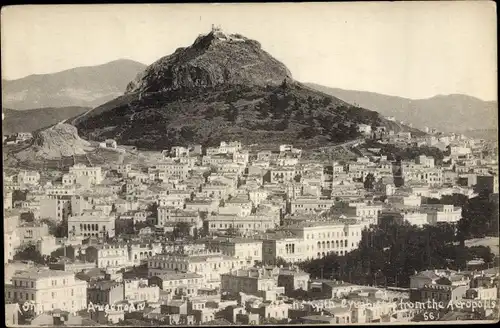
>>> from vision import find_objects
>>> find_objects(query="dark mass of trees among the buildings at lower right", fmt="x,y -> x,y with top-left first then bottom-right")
301,220 -> 493,287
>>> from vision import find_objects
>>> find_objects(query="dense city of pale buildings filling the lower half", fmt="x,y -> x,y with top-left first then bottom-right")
4,126 -> 499,325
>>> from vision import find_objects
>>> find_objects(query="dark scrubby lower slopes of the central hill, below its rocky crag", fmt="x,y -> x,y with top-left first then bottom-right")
73,82 -> 416,150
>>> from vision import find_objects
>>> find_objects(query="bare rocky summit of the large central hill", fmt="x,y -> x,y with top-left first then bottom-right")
126,27 -> 292,93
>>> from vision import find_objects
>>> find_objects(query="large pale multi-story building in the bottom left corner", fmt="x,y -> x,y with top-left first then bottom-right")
5,269 -> 87,313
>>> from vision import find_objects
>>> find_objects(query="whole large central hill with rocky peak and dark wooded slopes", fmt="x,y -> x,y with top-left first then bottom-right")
71,30 -> 421,150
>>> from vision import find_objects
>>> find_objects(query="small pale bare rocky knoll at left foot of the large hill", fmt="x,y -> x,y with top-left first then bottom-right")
15,123 -> 93,161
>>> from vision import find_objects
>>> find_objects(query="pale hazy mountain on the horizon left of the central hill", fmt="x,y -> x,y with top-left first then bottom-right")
2,59 -> 146,110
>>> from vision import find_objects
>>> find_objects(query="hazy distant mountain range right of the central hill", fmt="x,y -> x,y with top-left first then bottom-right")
306,83 -> 498,132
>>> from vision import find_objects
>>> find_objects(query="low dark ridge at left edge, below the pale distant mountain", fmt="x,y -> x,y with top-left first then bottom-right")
2,107 -> 90,135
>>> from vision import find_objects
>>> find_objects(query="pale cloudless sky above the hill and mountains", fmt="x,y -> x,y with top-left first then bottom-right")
1,1 -> 497,100
